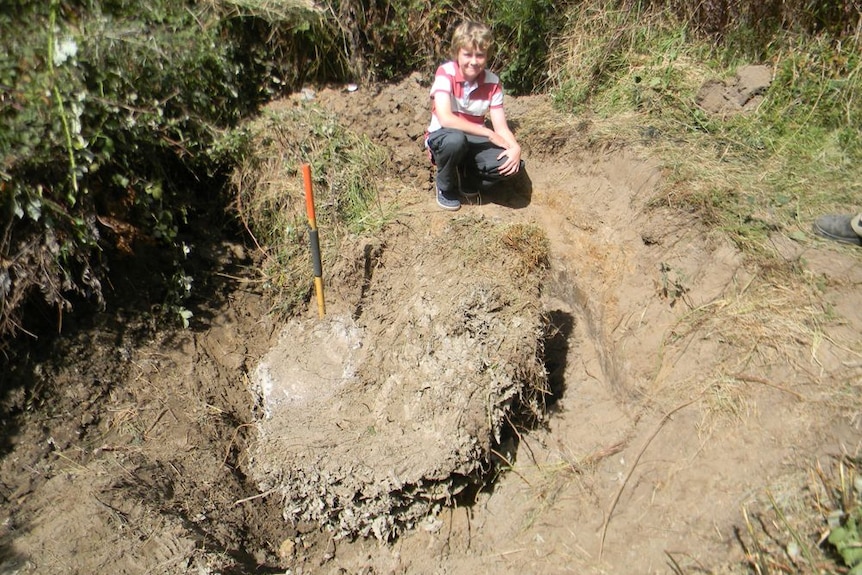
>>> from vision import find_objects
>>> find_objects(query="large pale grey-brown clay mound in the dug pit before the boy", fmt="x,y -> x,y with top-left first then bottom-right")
251,217 -> 547,540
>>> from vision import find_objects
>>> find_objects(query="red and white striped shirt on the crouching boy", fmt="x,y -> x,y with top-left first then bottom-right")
428,62 -> 503,133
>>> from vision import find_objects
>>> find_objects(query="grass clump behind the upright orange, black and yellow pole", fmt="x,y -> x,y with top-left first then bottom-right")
232,103 -> 390,313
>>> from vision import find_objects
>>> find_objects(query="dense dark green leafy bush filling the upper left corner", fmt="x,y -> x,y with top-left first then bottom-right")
0,0 -> 318,342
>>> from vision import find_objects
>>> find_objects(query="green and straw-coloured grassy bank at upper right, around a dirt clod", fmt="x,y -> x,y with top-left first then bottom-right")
551,0 -> 862,258
